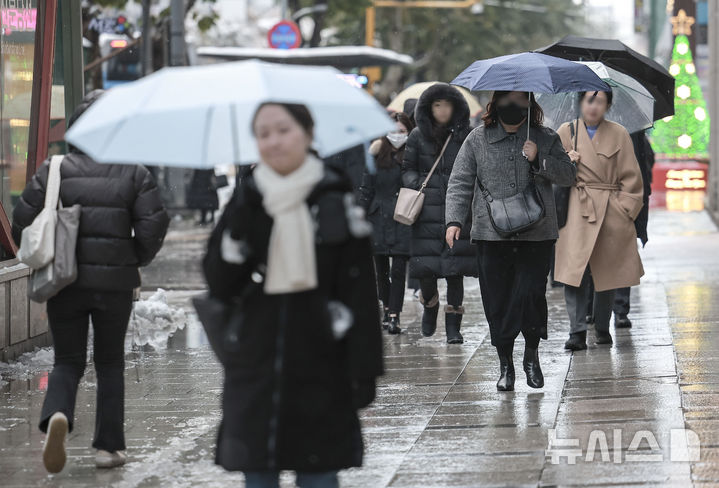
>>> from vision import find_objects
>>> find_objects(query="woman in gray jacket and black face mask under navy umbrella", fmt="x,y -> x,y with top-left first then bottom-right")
446,91 -> 577,391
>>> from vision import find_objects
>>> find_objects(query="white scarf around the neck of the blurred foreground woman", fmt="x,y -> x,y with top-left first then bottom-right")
254,155 -> 324,295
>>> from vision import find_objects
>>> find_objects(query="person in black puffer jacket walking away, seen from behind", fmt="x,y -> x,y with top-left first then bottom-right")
13,90 -> 170,472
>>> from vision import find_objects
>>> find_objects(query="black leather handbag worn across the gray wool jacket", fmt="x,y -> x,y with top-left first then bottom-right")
477,176 -> 544,237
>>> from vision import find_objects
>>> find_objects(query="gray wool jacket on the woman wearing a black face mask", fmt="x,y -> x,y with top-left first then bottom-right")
445,123 -> 577,241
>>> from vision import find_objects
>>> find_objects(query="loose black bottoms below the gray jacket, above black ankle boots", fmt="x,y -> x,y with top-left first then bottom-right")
477,241 -> 554,349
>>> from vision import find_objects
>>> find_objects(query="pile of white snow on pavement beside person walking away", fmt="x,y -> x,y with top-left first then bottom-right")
125,288 -> 187,350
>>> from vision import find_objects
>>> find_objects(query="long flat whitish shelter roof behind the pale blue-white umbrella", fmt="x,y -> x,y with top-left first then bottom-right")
197,46 -> 414,68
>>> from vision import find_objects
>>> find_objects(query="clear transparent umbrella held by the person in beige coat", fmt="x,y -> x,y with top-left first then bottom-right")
537,61 -> 654,133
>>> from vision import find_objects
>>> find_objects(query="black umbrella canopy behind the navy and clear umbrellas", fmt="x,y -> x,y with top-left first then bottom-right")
537,36 -> 674,120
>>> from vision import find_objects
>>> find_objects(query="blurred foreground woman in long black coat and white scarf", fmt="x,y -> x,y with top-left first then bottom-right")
204,104 -> 383,488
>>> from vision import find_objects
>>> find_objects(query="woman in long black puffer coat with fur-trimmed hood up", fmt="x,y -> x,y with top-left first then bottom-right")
402,83 -> 477,344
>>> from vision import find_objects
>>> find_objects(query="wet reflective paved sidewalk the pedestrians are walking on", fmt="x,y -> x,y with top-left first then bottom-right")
0,210 -> 719,488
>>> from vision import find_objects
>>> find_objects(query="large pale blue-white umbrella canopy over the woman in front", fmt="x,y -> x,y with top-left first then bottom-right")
66,60 -> 395,168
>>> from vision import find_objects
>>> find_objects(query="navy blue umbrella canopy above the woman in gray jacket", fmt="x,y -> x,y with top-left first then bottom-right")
452,53 -> 609,93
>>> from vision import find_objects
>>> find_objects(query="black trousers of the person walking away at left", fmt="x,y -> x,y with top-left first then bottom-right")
40,289 -> 132,452
